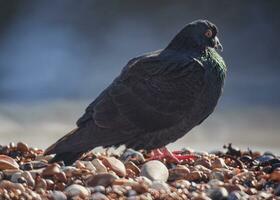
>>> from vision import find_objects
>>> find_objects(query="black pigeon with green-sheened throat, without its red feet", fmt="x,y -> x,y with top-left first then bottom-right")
44,20 -> 227,165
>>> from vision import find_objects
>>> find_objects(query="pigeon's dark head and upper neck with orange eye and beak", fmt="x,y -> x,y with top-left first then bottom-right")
168,20 -> 223,50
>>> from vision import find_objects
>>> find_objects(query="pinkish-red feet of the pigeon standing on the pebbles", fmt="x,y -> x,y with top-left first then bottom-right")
149,147 -> 197,163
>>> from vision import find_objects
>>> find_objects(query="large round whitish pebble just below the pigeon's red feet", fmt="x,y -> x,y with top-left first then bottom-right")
140,160 -> 169,182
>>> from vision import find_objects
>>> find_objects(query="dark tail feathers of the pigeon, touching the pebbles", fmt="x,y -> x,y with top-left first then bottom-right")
44,128 -> 87,165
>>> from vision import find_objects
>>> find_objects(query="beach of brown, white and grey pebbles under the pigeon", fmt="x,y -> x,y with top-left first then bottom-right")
0,142 -> 280,200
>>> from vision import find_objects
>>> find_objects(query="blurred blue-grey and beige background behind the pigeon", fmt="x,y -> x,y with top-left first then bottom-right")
0,0 -> 280,153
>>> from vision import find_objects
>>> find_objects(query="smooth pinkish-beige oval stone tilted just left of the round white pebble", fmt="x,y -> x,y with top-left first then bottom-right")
102,157 -> 126,177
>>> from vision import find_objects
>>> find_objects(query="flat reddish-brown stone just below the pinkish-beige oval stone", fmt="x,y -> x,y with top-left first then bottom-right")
87,173 -> 118,187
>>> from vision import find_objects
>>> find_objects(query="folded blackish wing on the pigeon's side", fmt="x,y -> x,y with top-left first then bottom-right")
77,54 -> 205,132
